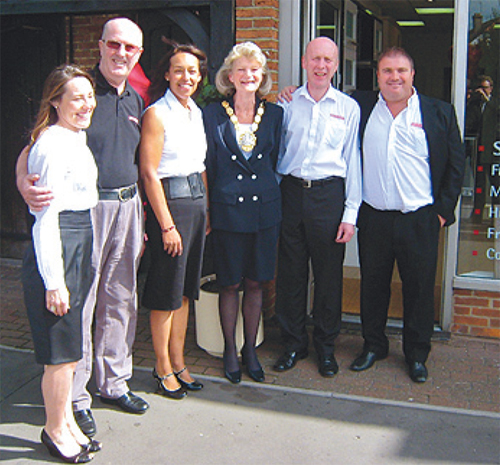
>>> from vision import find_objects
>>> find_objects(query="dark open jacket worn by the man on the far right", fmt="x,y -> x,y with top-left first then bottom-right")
352,91 -> 465,226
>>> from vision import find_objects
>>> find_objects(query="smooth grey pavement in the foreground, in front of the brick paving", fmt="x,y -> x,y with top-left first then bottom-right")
0,347 -> 500,465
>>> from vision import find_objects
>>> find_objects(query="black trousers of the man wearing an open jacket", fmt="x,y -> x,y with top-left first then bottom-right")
358,203 -> 440,362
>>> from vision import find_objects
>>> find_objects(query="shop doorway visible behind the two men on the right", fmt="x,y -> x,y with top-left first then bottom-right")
304,0 -> 454,324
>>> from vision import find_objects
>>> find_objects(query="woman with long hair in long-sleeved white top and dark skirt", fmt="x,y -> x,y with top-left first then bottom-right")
23,65 -> 101,463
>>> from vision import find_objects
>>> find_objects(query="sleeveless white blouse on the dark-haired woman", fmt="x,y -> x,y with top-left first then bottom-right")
146,89 -> 207,179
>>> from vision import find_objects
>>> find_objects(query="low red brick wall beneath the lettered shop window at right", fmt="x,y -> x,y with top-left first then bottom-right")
451,289 -> 500,338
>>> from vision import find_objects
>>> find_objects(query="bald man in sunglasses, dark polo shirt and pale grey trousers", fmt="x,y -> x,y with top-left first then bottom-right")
17,18 -> 149,436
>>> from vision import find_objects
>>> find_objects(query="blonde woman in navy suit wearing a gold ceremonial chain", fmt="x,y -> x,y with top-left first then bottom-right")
203,42 -> 283,383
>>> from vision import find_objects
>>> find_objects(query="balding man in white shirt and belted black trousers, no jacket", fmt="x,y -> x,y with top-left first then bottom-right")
274,37 -> 361,377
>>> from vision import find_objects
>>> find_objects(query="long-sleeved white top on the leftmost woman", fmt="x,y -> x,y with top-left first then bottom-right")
28,125 -> 98,290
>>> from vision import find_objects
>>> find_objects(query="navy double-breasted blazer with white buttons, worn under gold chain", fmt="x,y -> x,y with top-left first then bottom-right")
203,99 -> 283,233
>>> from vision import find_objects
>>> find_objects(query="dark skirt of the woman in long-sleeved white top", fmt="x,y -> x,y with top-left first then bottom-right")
22,210 -> 93,365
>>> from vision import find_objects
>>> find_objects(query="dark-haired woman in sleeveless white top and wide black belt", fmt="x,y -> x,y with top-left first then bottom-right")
140,44 -> 207,399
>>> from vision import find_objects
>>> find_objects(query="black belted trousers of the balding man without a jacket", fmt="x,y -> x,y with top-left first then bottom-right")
276,176 -> 345,357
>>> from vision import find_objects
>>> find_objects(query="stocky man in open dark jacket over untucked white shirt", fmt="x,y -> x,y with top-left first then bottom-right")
350,47 -> 465,383
